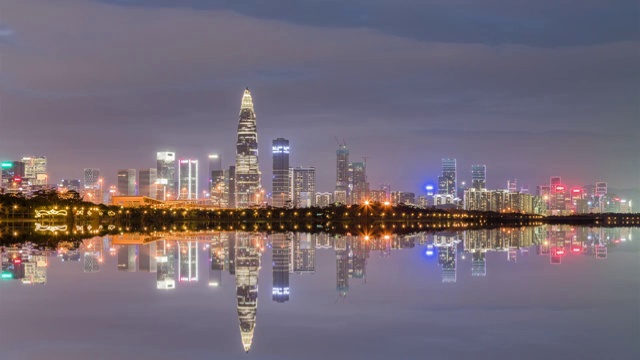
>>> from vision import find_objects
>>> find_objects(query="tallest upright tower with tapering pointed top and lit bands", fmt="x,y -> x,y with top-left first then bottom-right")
235,88 -> 262,208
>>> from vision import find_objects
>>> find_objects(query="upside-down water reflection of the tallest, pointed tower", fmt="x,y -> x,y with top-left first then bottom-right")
235,233 -> 260,353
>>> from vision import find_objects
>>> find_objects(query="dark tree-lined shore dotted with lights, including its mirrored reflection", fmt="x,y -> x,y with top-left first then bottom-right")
0,191 -> 640,245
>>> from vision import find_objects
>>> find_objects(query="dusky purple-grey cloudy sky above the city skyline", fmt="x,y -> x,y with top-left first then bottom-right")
0,0 -> 640,193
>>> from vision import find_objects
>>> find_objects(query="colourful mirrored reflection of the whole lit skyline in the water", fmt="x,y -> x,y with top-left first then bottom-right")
2,226 -> 633,351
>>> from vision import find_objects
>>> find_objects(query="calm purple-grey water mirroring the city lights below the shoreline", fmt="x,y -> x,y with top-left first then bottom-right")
0,226 -> 640,360
